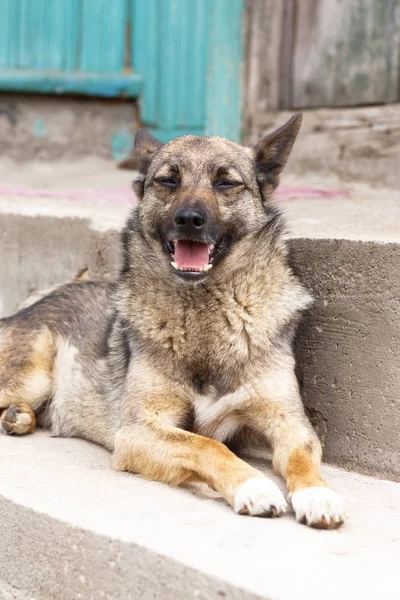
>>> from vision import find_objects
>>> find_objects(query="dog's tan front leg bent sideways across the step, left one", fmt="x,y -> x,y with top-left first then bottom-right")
113,375 -> 286,517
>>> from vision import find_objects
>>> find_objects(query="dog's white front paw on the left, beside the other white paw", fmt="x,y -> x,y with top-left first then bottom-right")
233,477 -> 287,517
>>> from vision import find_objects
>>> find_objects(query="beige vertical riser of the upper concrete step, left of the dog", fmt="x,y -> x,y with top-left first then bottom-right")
0,214 -> 118,317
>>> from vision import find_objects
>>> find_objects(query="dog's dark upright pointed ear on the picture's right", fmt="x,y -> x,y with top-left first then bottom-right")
253,113 -> 303,198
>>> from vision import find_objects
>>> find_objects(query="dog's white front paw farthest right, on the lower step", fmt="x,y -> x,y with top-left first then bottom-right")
291,487 -> 347,529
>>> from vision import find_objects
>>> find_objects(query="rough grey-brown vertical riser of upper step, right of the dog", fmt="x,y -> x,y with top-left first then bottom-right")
292,239 -> 400,480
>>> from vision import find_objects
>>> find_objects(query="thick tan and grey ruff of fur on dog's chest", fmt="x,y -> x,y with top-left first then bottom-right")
125,262 -> 304,399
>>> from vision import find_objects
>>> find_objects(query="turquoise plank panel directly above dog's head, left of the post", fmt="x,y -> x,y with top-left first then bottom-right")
133,0 -> 212,141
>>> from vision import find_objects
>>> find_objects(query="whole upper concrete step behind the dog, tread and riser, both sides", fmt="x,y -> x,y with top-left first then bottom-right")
0,159 -> 400,480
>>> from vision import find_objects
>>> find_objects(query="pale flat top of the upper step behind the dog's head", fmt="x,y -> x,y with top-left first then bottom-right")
0,162 -> 400,242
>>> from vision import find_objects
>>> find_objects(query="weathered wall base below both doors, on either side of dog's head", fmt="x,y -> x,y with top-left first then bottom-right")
0,96 -> 400,188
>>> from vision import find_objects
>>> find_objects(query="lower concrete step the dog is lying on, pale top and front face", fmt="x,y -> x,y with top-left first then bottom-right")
0,431 -> 400,600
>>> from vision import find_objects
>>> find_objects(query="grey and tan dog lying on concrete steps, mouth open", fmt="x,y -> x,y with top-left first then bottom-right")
0,115 -> 346,529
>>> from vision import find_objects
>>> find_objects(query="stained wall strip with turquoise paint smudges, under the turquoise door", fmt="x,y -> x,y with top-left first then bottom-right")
0,94 -> 139,161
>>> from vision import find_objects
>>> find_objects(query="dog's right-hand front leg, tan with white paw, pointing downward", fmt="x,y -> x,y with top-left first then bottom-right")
242,363 -> 346,529
